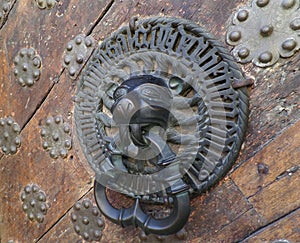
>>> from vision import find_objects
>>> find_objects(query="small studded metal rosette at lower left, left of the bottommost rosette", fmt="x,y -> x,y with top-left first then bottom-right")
21,185 -> 47,223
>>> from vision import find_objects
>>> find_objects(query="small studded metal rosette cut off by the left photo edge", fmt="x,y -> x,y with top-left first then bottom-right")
0,117 -> 21,154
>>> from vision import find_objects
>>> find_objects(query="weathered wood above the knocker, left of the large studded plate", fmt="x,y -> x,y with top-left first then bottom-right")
92,0 -> 247,42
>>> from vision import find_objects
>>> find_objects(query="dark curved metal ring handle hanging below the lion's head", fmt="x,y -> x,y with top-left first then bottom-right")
94,181 -> 190,235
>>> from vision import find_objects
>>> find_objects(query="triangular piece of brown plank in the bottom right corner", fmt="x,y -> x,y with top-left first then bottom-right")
242,209 -> 300,243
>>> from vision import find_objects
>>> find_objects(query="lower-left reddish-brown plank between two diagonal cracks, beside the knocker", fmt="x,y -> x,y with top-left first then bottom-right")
0,71 -> 92,242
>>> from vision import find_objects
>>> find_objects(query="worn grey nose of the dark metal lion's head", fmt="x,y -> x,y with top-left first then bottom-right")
113,98 -> 135,124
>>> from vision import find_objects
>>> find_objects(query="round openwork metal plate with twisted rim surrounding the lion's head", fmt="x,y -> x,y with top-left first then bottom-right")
75,18 -> 248,197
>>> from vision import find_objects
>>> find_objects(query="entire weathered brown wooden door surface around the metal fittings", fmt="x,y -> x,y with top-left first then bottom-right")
0,0 -> 300,243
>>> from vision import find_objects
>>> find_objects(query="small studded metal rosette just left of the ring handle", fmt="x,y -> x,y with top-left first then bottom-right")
71,199 -> 105,242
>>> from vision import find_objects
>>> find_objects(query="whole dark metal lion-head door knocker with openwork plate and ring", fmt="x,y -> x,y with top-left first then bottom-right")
75,18 -> 248,235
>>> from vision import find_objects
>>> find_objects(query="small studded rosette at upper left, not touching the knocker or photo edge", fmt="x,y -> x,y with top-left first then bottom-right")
14,48 -> 42,87
